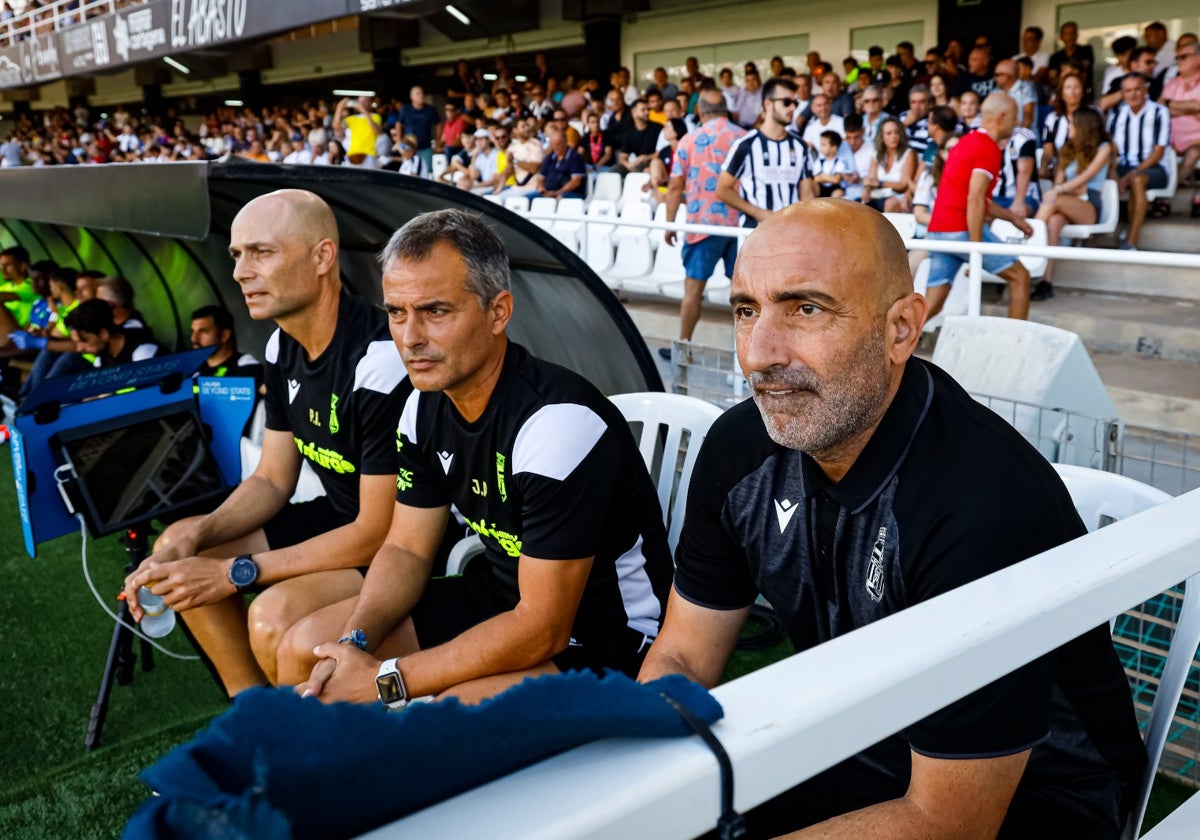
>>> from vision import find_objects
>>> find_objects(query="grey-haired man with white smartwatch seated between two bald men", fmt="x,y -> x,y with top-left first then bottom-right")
288,206 -> 676,709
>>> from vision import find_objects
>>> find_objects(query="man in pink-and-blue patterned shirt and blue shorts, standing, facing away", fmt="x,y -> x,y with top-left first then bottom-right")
659,90 -> 745,359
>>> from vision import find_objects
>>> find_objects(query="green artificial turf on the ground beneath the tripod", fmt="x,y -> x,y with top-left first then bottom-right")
0,446 -> 1194,840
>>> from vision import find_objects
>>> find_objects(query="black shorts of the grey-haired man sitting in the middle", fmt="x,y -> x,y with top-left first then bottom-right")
412,558 -> 654,677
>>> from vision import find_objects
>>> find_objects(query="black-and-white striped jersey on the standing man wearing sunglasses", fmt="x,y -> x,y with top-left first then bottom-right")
721,130 -> 812,228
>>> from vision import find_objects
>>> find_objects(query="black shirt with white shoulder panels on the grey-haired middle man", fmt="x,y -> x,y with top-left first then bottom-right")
396,342 -> 672,647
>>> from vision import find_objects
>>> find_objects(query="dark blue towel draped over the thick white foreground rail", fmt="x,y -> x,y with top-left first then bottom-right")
124,671 -> 724,840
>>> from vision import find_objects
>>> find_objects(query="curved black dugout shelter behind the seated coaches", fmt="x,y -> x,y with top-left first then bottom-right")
0,162 -> 662,395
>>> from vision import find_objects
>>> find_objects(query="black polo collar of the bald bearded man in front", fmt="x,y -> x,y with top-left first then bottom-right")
803,359 -> 934,514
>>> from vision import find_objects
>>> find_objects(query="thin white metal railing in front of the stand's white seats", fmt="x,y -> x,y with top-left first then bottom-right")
517,212 -> 1200,316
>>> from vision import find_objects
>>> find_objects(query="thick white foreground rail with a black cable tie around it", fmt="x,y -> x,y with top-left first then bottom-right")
366,491 -> 1200,840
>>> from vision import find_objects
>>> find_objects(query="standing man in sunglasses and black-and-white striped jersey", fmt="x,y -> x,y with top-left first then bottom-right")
716,79 -> 816,228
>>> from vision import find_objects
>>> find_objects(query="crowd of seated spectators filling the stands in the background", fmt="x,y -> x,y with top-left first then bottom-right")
0,22 -> 1200,312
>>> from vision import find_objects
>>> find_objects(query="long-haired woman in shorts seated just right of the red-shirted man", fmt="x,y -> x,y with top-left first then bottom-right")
1030,108 -> 1112,300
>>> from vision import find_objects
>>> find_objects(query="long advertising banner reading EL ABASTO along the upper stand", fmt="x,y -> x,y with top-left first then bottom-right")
0,0 -> 360,89
